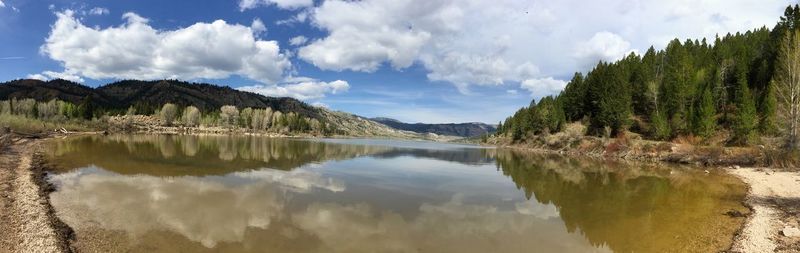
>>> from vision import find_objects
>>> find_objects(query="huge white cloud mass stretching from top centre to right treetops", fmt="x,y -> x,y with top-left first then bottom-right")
298,0 -> 792,94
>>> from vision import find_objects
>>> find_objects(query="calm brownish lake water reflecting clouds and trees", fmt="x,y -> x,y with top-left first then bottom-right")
48,135 -> 747,252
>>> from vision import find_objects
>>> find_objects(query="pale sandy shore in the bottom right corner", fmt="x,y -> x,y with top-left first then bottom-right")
731,168 -> 800,252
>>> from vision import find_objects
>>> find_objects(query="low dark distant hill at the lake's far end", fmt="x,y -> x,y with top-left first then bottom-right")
371,117 -> 497,137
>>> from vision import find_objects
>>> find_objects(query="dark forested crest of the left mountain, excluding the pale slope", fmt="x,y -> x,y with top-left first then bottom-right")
0,79 -> 319,118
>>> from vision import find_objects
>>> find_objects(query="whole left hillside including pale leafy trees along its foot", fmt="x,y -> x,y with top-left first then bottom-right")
0,79 -> 417,138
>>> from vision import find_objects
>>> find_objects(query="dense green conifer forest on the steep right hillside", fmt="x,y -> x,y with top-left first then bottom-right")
498,5 -> 800,145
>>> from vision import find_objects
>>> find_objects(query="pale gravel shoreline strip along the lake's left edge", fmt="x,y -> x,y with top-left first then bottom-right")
0,139 -> 69,252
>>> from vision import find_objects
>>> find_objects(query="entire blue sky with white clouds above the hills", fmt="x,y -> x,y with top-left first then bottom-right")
0,0 -> 793,123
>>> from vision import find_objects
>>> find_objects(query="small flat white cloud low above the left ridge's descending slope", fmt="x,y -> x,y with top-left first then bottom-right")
237,80 -> 350,100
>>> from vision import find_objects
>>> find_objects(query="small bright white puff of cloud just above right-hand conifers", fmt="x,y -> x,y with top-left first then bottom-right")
575,32 -> 638,67
